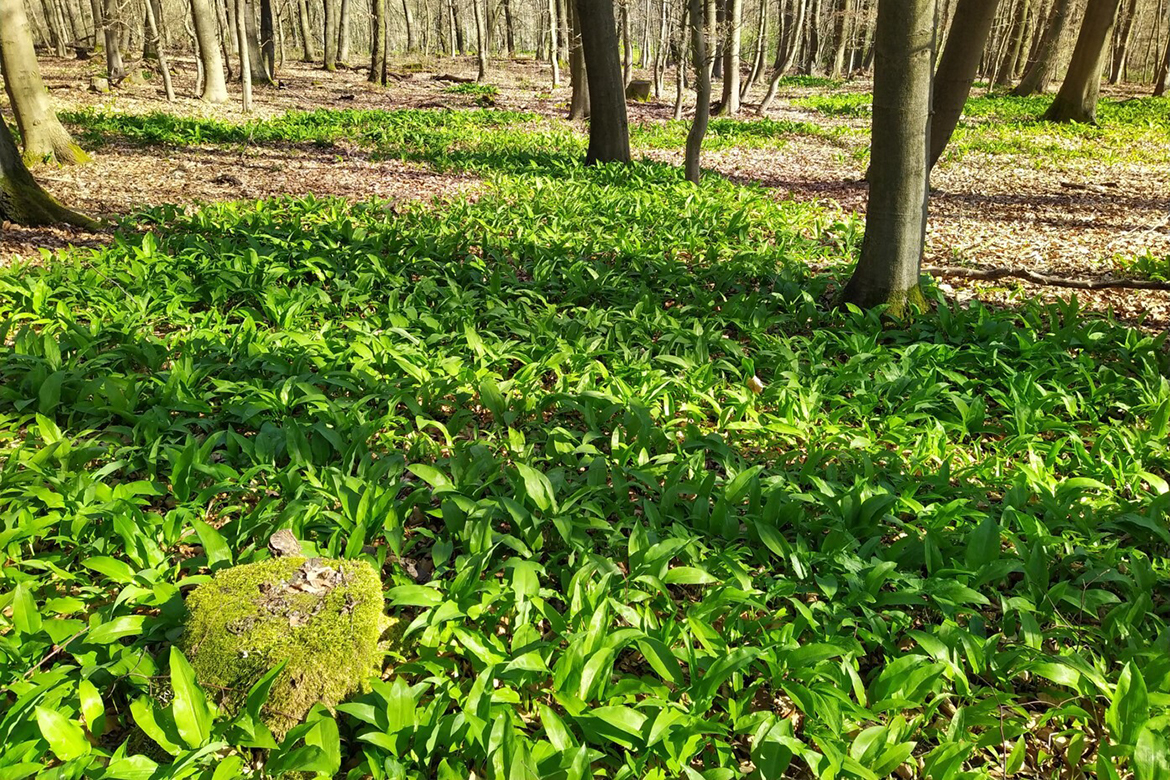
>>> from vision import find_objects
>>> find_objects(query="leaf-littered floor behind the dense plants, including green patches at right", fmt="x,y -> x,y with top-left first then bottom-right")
0,50 -> 1170,330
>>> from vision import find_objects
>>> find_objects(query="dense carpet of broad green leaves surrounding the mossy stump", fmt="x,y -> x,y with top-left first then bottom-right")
0,99 -> 1170,780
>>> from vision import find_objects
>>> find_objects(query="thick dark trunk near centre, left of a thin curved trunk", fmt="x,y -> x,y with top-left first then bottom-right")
577,0 -> 629,165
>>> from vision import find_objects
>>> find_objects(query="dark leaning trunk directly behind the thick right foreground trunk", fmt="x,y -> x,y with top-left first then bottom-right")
930,0 -> 999,168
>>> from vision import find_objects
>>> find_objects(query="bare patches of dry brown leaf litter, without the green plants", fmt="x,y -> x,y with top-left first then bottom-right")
0,57 -> 1170,330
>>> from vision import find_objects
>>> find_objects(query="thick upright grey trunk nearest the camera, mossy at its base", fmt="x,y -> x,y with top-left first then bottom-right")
841,0 -> 937,317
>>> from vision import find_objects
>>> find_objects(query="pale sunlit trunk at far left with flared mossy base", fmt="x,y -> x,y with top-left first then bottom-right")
0,0 -> 89,165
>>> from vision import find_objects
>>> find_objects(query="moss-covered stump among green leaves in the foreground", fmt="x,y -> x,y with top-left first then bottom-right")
181,558 -> 386,736
